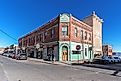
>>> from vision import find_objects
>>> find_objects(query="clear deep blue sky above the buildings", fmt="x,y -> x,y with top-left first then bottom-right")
0,0 -> 121,51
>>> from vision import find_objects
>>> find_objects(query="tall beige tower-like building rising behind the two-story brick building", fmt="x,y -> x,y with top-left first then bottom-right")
83,11 -> 103,57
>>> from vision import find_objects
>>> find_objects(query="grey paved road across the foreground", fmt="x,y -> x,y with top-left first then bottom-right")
0,56 -> 121,81
